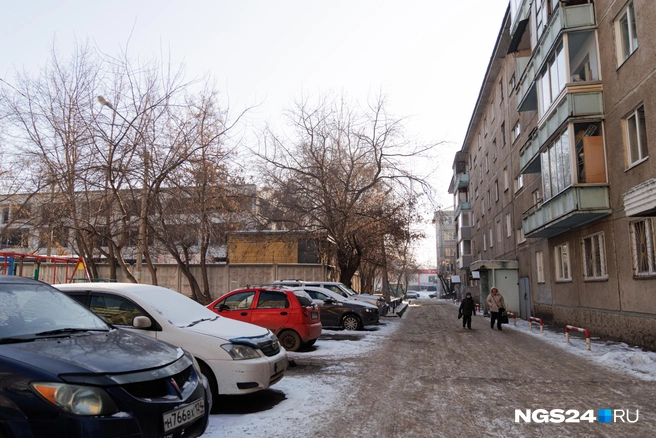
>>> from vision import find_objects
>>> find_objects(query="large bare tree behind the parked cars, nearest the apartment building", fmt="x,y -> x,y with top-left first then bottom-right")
259,93 -> 436,285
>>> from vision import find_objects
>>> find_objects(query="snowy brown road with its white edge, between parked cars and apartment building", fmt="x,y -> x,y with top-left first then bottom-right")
207,299 -> 656,438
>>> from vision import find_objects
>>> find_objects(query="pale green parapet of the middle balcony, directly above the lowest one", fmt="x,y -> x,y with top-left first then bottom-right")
519,83 -> 604,173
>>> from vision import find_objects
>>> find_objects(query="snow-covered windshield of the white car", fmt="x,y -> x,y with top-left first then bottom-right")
136,287 -> 217,327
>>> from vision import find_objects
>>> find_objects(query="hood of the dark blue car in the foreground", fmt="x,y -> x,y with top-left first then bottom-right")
0,330 -> 184,380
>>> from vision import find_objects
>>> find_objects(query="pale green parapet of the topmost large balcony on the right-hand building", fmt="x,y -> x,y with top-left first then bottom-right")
517,3 -> 595,111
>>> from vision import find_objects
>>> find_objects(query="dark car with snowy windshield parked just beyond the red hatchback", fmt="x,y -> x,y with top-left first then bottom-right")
294,286 -> 379,330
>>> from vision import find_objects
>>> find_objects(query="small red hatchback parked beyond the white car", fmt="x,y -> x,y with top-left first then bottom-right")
207,287 -> 322,351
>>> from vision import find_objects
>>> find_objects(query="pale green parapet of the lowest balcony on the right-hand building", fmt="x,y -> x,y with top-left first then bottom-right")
522,186 -> 611,238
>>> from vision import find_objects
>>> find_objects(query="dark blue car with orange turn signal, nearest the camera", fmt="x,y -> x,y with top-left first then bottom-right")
0,276 -> 212,438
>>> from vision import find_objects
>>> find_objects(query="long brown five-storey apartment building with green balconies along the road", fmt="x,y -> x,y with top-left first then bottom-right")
450,0 -> 656,348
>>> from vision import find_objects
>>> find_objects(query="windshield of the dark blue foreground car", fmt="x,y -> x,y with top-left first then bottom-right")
0,283 -> 110,342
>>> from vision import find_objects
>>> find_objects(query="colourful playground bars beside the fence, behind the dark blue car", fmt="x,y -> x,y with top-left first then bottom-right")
0,251 -> 91,284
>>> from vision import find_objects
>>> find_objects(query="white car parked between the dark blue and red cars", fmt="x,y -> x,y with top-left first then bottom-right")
55,283 -> 287,406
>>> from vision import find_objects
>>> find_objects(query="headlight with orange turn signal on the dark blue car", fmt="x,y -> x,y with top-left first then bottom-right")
31,382 -> 118,416
